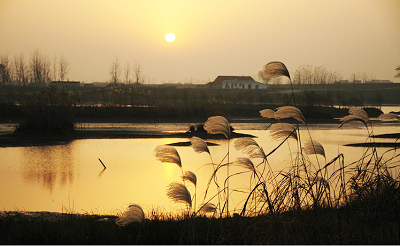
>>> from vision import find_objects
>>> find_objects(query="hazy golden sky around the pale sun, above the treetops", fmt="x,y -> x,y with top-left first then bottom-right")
0,0 -> 400,83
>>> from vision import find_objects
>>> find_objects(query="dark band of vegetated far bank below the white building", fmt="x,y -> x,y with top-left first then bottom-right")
0,83 -> 394,119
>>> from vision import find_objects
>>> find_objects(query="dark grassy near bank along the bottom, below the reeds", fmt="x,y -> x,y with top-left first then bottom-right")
0,207 -> 400,244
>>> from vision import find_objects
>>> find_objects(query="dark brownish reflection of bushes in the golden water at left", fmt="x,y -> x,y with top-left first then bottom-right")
23,144 -> 74,191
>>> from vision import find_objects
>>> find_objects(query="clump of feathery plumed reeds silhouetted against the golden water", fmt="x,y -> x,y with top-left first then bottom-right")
133,63 -> 398,221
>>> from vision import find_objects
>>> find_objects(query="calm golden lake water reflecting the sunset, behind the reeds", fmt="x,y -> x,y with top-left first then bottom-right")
0,105 -> 400,214
